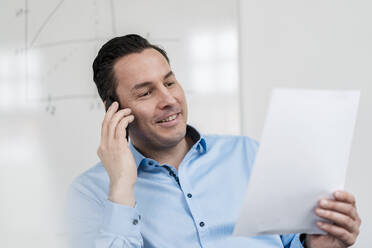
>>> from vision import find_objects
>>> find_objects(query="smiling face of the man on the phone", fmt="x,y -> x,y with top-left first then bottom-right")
114,48 -> 187,149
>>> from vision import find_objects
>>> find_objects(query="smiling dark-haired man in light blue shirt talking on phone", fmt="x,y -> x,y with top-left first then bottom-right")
69,35 -> 360,248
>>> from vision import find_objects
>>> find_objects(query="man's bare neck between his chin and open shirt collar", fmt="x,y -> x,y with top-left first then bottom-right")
134,136 -> 194,170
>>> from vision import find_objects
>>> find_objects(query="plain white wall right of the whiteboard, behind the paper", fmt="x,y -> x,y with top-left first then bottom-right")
239,0 -> 372,248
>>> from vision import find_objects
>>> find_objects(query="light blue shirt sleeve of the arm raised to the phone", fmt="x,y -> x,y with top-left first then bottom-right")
66,183 -> 143,248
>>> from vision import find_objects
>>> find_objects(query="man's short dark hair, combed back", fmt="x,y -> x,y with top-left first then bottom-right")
93,34 -> 169,101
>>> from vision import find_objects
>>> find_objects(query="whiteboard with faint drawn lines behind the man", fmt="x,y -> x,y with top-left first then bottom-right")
0,0 -> 240,248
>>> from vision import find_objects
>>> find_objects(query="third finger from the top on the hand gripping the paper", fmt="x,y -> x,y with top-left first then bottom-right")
315,208 -> 358,233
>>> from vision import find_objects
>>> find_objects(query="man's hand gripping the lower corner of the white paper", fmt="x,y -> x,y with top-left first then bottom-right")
306,191 -> 361,248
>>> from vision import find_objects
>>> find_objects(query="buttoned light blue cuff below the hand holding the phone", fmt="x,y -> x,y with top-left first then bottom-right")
101,200 -> 141,237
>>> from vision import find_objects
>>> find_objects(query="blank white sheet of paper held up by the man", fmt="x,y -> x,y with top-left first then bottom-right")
234,89 -> 360,236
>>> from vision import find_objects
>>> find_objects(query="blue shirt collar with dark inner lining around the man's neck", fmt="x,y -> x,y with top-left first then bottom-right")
129,125 -> 207,168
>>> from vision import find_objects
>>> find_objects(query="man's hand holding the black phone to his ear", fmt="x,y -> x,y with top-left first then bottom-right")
97,102 -> 137,207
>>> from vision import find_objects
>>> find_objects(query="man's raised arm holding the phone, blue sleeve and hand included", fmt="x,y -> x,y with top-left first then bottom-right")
68,102 -> 143,248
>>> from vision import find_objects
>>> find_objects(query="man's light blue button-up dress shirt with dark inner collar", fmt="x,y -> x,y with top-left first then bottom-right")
68,126 -> 302,248
